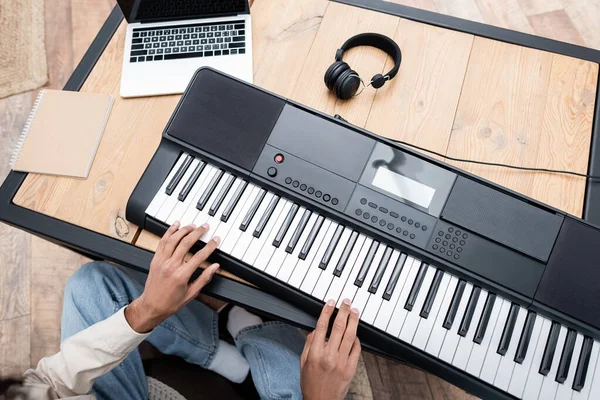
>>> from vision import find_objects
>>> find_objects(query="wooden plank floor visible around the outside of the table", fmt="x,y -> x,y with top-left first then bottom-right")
0,0 -> 600,399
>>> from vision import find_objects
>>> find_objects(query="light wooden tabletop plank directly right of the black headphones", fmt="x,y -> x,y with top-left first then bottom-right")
366,19 -> 473,154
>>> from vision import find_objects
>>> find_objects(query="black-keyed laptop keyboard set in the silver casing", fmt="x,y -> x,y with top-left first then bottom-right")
129,20 -> 246,62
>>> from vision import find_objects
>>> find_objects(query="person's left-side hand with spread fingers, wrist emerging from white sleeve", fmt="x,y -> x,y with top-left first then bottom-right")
125,222 -> 220,333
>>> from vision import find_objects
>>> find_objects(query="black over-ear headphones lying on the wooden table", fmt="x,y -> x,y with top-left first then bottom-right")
324,33 -> 402,100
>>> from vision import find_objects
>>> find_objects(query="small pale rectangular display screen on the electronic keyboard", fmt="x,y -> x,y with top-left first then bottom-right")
371,167 -> 435,209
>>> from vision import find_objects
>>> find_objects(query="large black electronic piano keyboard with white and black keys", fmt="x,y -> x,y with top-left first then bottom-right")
127,68 -> 600,400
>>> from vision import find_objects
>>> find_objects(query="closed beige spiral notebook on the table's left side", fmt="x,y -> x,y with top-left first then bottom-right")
10,89 -> 113,178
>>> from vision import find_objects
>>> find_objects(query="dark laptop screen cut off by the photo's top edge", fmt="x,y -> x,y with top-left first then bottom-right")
117,0 -> 248,22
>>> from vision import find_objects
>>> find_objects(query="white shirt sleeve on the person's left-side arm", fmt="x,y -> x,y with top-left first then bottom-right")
23,307 -> 150,398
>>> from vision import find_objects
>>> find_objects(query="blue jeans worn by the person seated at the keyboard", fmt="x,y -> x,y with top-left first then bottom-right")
61,262 -> 305,399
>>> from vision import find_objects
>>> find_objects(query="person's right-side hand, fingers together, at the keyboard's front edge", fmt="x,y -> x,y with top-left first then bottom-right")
300,299 -> 360,400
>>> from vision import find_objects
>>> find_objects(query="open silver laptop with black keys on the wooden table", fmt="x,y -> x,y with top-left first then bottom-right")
117,0 -> 252,97
